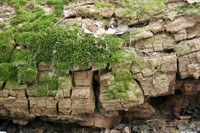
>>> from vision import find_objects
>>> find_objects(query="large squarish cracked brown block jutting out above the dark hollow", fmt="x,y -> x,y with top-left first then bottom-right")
131,53 -> 177,97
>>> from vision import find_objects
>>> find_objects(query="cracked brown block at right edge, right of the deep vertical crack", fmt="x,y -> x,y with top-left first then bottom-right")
175,38 -> 200,79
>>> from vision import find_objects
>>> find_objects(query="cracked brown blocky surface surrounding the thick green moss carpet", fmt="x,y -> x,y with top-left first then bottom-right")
0,0 -> 200,128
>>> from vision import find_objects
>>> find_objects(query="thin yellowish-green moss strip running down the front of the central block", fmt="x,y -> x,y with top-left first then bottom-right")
104,49 -> 137,100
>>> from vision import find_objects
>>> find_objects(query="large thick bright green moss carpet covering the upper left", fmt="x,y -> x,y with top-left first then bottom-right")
0,0 -> 124,96
